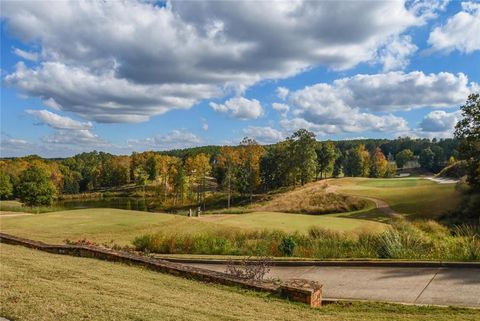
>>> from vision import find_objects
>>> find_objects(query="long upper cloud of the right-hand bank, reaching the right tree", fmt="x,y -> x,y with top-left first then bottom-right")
289,71 -> 478,112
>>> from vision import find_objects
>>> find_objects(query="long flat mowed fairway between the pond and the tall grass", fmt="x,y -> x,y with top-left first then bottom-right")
0,208 -> 385,245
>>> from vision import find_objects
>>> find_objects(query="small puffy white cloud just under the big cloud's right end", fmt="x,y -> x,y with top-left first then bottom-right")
378,36 -> 418,71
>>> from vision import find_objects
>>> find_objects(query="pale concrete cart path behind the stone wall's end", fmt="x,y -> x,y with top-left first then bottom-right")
189,264 -> 480,308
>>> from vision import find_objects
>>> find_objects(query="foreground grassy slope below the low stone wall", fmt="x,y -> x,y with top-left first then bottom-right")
0,244 -> 480,321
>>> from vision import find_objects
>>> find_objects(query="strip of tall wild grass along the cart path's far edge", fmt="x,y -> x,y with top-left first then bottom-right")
133,221 -> 480,261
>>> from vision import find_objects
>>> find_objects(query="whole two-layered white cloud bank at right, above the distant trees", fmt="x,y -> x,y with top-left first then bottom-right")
280,71 -> 477,134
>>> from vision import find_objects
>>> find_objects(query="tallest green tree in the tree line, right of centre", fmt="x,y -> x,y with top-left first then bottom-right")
289,129 -> 317,185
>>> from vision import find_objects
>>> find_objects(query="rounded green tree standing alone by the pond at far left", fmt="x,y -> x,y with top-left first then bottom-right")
18,166 -> 56,206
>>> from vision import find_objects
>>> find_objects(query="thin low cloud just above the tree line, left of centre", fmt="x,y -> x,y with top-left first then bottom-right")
127,129 -> 203,149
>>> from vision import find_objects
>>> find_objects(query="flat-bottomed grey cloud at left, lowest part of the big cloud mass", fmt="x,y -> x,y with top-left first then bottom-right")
5,62 -> 218,123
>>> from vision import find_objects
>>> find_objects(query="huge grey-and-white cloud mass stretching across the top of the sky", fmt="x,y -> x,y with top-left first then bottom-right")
2,0 -> 434,122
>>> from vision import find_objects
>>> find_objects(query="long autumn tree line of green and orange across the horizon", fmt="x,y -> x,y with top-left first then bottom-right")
0,129 -> 459,207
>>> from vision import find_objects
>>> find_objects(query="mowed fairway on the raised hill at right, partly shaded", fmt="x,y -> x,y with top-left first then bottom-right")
329,177 -> 461,218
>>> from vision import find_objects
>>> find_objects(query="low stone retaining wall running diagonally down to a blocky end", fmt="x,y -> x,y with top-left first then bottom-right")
0,233 -> 322,307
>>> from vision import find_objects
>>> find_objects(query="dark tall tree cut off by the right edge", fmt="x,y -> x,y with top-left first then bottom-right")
455,93 -> 480,190
